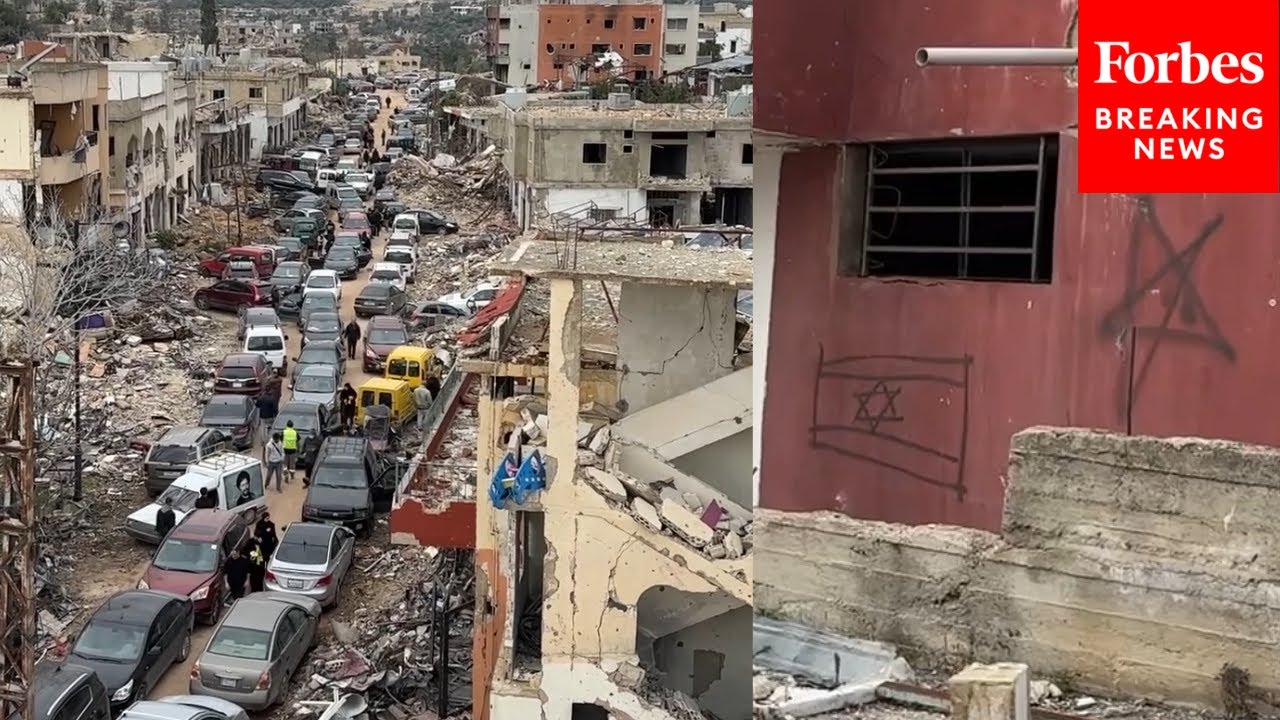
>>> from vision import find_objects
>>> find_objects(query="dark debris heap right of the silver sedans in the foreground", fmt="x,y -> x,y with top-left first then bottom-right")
285,547 -> 475,720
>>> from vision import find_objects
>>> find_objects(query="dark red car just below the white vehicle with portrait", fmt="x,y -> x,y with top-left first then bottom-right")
138,510 -> 251,625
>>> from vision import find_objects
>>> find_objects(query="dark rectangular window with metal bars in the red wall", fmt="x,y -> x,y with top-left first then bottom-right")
859,136 -> 1057,283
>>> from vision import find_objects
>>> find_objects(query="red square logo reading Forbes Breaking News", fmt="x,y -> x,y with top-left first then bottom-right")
1078,0 -> 1280,193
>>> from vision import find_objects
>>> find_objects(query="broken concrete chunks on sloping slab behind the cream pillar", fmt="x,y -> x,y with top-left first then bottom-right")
503,395 -> 754,560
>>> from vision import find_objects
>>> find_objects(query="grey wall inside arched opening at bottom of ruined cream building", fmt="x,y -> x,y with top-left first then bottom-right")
653,605 -> 753,720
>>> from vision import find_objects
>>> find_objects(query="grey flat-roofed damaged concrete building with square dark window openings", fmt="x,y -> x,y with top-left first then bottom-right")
451,92 -> 754,229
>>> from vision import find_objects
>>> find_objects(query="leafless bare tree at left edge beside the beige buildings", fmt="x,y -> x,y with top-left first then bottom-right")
0,208 -> 161,462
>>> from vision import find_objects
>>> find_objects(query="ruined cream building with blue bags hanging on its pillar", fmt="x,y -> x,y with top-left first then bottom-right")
461,241 -> 751,720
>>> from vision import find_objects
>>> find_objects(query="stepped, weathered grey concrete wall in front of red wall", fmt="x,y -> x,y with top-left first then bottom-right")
755,428 -> 1280,706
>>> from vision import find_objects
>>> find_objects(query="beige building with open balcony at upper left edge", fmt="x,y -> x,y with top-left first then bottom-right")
0,60 -> 110,229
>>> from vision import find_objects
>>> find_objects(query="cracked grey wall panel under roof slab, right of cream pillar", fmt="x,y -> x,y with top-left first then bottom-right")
617,283 -> 737,413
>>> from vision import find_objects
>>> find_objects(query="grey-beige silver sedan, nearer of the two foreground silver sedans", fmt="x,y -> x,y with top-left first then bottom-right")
191,592 -> 321,711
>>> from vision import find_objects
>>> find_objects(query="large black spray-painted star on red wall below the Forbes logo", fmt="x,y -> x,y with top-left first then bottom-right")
1098,196 -> 1235,416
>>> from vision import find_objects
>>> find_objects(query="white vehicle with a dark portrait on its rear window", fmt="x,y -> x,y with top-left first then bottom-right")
124,452 -> 266,544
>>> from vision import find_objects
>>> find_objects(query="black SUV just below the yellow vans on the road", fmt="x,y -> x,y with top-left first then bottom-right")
302,436 -> 397,537
